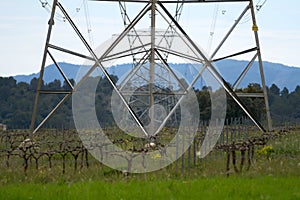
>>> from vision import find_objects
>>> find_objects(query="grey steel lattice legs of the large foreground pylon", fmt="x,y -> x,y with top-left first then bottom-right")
31,0 -> 272,137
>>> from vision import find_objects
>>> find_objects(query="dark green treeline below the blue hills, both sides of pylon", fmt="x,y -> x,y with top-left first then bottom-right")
0,76 -> 300,129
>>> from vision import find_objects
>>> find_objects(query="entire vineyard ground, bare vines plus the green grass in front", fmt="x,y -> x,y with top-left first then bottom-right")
0,119 -> 300,199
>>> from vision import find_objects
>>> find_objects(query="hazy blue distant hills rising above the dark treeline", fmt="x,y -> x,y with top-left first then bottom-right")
14,59 -> 300,91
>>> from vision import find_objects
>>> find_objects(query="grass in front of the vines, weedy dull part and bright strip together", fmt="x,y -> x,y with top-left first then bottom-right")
0,127 -> 300,200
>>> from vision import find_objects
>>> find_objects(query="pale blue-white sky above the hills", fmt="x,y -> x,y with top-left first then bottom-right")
0,0 -> 300,76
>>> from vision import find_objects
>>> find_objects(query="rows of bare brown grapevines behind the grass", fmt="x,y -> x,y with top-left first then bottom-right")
0,118 -> 300,175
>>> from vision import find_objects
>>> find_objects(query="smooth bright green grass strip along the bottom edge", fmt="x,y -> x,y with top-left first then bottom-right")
0,176 -> 300,199
